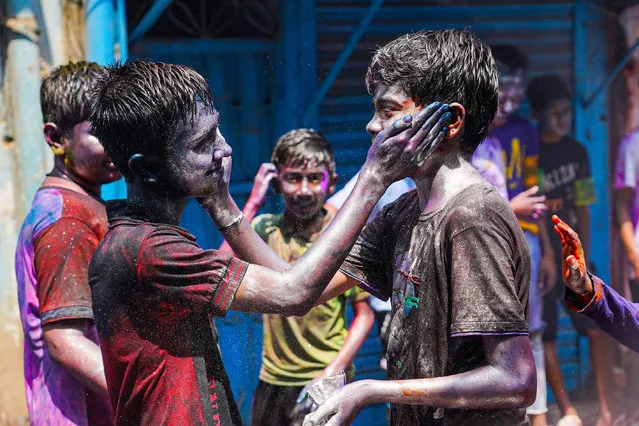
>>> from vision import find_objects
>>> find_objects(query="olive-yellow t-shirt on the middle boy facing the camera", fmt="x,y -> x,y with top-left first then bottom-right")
252,213 -> 369,386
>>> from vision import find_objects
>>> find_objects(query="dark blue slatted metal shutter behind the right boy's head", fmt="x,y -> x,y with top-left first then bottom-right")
317,0 -> 573,183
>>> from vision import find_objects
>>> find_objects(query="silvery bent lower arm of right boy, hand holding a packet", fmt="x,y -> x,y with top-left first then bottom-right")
304,335 -> 536,426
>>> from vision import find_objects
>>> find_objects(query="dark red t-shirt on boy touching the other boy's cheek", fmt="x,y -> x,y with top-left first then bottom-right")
89,201 -> 248,425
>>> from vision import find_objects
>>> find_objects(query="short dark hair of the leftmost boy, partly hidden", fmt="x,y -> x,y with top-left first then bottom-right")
40,61 -> 104,137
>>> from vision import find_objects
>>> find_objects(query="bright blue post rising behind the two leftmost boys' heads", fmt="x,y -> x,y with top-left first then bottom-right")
85,0 -> 126,200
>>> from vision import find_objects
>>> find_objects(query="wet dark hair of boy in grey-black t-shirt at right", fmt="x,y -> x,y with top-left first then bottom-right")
366,29 -> 499,155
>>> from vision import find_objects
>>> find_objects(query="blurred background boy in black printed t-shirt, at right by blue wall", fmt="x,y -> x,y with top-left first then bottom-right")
528,74 -> 612,425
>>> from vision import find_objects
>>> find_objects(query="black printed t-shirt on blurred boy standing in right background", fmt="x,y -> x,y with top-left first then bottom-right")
539,136 -> 595,267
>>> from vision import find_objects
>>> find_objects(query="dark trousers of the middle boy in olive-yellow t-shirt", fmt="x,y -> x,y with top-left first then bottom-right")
252,380 -> 304,426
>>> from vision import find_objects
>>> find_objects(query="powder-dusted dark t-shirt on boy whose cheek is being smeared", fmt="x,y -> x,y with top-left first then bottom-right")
341,183 -> 530,426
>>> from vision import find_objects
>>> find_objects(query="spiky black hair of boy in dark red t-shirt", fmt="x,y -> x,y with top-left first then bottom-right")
90,60 -> 214,177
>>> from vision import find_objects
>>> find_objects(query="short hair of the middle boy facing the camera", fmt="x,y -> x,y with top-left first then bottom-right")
271,129 -> 335,176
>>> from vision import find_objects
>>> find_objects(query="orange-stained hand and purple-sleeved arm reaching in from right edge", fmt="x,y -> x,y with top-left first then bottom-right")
552,216 -> 639,352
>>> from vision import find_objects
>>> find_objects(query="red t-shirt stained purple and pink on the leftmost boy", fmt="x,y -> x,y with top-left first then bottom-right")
15,177 -> 114,426
